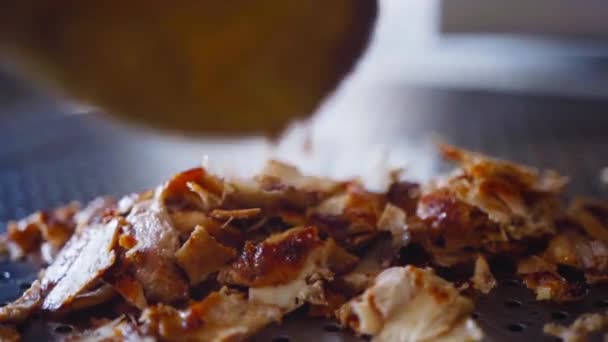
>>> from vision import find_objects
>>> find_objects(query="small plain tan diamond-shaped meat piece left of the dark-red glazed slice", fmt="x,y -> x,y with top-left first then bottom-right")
175,226 -> 237,284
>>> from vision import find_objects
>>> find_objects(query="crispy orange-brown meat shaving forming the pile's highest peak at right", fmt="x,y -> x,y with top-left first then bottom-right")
439,146 -> 567,240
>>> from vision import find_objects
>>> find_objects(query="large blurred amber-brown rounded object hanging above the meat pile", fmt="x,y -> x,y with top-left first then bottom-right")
0,0 -> 377,134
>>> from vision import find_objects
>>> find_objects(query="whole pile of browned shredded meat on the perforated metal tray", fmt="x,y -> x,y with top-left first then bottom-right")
0,146 -> 608,341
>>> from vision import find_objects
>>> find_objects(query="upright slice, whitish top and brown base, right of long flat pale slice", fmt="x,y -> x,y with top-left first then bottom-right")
124,200 -> 188,303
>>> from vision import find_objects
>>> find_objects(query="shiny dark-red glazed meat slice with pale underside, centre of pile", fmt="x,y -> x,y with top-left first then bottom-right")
218,227 -> 357,312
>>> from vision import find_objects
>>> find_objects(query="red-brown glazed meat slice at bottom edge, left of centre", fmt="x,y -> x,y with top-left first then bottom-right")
140,288 -> 282,342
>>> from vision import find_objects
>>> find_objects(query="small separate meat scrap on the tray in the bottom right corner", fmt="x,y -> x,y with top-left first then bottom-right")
543,313 -> 608,342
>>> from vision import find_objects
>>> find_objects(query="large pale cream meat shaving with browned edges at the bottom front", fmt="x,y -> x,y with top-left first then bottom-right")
338,266 -> 482,341
